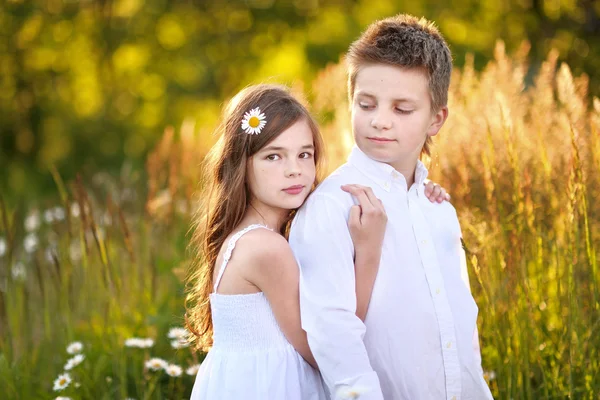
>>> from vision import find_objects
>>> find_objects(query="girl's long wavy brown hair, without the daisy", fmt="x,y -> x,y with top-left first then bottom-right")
186,84 -> 323,351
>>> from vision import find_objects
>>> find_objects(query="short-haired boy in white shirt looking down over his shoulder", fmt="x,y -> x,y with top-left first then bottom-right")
290,15 -> 492,400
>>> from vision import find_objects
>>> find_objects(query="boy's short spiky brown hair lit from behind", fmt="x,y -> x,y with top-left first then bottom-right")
346,14 -> 452,155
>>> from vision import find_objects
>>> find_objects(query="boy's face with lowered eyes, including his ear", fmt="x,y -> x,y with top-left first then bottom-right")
352,64 -> 448,172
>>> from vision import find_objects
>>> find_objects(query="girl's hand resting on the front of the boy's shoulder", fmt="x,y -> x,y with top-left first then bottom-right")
342,185 -> 387,265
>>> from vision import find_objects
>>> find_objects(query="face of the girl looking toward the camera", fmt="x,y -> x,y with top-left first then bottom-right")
247,119 -> 316,210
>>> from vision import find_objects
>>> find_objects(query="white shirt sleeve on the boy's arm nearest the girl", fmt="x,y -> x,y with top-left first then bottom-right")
290,193 -> 383,400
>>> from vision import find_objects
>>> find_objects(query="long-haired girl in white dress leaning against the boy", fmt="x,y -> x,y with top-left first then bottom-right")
186,85 -> 445,400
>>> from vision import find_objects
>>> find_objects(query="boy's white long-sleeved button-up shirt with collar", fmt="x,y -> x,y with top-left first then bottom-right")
289,147 -> 492,400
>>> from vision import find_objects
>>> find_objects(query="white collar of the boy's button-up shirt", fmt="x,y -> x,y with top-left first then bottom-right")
348,145 -> 428,192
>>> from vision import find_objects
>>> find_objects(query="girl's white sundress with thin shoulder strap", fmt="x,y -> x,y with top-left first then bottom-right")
191,225 -> 327,400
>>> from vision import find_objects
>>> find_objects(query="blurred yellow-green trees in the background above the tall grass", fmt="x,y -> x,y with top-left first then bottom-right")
0,0 -> 600,199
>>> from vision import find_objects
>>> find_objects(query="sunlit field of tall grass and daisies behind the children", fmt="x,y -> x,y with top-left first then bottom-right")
0,43 -> 600,400
